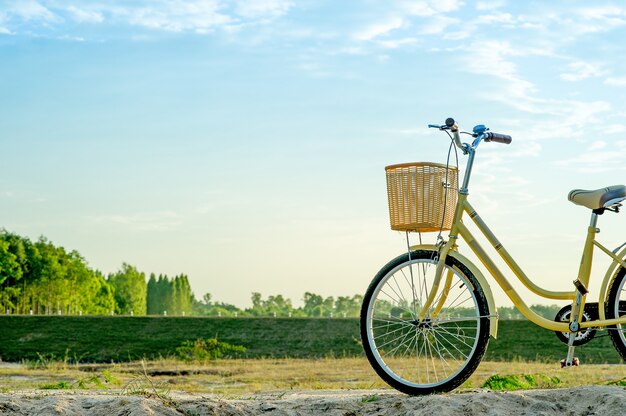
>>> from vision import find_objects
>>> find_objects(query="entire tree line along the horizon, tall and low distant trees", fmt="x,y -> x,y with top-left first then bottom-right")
0,229 -> 559,319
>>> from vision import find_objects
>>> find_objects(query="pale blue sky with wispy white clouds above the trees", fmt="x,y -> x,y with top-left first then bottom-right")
0,0 -> 626,306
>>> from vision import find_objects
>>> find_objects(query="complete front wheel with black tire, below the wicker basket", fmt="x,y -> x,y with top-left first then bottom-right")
361,250 -> 489,395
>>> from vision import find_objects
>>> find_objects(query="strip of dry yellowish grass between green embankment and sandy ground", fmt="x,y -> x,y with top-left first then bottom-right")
0,358 -> 626,397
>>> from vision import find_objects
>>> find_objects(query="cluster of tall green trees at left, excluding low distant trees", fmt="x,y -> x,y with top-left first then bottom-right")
0,229 -> 195,315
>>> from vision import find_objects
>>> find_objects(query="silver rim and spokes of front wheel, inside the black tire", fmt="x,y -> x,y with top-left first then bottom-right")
367,259 -> 481,388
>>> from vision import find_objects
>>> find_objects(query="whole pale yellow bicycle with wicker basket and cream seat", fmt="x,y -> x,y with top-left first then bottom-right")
361,118 -> 626,395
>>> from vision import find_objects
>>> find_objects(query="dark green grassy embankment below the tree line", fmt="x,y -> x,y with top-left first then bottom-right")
0,316 -> 622,364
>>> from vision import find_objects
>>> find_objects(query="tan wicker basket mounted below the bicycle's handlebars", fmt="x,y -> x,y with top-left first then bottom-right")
385,162 -> 459,232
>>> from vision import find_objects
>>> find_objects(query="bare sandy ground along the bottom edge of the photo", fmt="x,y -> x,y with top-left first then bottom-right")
0,386 -> 626,416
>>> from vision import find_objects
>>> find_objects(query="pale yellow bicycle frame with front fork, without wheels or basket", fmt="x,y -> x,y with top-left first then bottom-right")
411,146 -> 626,332
